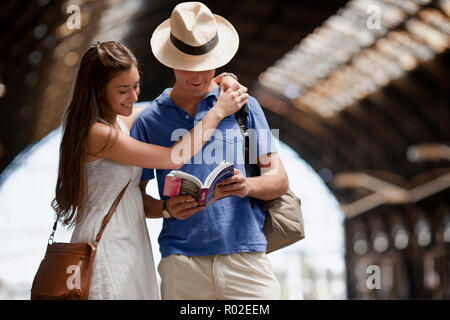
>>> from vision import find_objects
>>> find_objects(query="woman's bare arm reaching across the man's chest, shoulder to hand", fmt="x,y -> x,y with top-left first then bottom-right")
87,88 -> 248,169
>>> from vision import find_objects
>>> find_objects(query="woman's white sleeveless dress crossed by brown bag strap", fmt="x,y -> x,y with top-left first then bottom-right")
71,118 -> 159,300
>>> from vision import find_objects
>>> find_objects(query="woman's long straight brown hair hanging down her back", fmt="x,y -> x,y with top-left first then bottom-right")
52,41 -> 137,227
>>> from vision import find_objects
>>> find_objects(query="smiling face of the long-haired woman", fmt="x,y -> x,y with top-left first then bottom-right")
105,65 -> 140,117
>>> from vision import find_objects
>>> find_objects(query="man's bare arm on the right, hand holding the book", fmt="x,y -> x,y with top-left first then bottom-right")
218,153 -> 289,200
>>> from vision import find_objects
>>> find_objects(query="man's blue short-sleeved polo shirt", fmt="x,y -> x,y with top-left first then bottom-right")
131,87 -> 278,257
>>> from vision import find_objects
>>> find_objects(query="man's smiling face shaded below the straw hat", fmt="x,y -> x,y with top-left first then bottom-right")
173,69 -> 216,97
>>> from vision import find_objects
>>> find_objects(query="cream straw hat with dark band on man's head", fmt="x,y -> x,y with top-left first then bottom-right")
150,2 -> 239,71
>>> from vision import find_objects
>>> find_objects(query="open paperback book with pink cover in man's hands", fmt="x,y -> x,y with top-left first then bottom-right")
163,161 -> 234,205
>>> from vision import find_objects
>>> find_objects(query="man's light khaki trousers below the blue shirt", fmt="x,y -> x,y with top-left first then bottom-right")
158,252 -> 281,300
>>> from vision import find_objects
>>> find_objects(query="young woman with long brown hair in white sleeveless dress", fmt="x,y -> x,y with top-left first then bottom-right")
52,41 -> 248,299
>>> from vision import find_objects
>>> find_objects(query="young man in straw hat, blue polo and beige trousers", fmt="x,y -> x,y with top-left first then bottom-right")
131,2 -> 289,299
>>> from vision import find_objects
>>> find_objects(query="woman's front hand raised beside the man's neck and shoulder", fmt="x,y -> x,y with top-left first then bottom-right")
212,84 -> 248,119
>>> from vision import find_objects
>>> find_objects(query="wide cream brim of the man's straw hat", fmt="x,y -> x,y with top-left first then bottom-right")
150,14 -> 239,71
